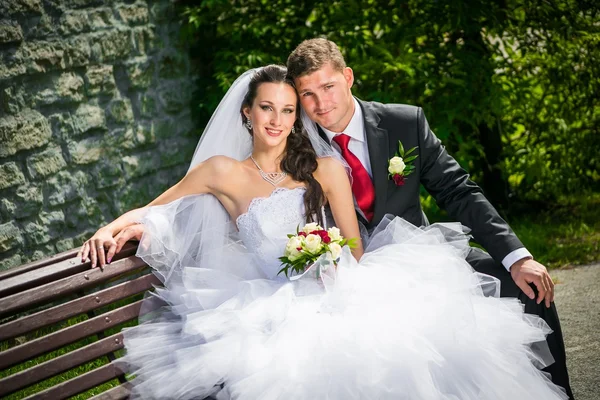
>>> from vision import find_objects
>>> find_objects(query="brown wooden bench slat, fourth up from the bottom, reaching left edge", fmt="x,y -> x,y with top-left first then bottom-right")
0,300 -> 144,369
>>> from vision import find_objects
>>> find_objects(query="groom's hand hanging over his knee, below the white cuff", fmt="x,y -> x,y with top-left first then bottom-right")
510,258 -> 554,308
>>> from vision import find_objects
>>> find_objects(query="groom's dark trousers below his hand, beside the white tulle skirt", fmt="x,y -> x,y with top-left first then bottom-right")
467,248 -> 573,399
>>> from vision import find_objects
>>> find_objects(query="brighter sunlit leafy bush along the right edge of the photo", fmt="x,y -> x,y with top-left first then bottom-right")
495,2 -> 600,202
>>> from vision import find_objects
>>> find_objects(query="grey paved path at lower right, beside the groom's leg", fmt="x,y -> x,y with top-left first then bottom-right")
550,263 -> 600,400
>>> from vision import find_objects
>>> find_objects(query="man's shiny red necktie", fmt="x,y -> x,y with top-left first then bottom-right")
333,133 -> 375,222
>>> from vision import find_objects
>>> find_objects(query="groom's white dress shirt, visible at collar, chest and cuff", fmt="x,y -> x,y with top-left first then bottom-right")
321,98 -> 533,271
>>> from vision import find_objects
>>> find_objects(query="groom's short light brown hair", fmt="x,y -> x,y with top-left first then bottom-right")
287,38 -> 346,79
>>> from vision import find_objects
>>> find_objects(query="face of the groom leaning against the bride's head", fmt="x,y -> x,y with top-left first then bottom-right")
295,63 -> 354,133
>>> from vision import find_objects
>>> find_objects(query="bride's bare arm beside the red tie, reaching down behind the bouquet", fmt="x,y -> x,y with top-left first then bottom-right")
314,157 -> 364,260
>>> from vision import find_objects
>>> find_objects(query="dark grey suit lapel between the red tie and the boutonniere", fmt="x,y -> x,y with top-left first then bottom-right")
357,99 -> 389,226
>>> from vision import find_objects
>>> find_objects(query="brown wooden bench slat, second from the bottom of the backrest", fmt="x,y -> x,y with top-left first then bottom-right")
26,364 -> 123,400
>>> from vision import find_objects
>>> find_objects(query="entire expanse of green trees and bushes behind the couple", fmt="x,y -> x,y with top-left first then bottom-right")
182,0 -> 600,206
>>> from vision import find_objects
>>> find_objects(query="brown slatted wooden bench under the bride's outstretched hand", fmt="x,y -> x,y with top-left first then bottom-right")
0,243 -> 160,400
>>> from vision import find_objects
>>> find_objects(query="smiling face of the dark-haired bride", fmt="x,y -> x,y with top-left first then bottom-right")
244,83 -> 298,147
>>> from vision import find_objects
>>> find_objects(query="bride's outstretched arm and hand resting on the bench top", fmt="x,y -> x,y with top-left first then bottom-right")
79,157 -> 229,268
